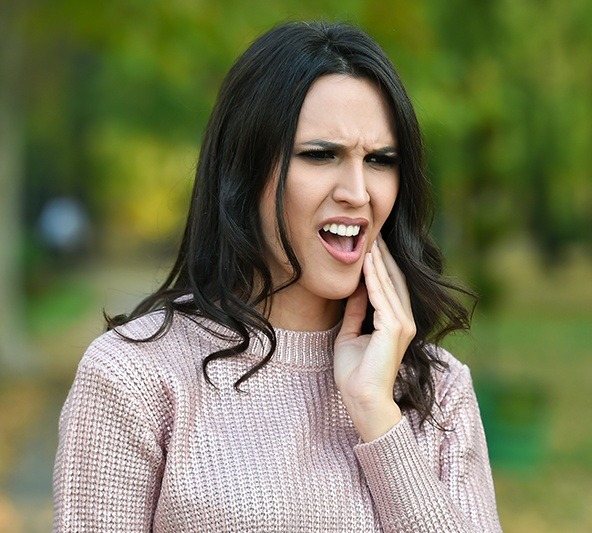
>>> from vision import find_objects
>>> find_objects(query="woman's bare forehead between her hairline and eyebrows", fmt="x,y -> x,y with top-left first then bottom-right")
296,74 -> 395,144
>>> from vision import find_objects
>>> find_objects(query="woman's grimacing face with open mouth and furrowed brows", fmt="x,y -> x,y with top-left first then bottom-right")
260,75 -> 399,324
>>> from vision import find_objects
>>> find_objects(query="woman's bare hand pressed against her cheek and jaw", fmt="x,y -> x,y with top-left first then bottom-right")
334,236 -> 416,442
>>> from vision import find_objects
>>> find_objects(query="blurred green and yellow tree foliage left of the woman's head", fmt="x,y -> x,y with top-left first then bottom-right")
20,0 -> 362,250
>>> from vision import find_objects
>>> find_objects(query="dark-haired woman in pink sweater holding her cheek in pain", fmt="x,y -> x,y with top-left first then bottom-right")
54,23 -> 500,533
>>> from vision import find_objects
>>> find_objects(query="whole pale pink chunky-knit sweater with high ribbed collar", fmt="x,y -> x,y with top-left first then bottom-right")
54,313 -> 501,533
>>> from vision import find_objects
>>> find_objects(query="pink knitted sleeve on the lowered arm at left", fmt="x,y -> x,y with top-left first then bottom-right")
53,352 -> 164,532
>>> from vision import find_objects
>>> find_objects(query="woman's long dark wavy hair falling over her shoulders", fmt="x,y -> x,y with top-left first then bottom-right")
107,22 -> 470,420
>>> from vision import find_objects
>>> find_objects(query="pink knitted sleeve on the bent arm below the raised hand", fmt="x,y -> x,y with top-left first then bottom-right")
355,360 -> 501,533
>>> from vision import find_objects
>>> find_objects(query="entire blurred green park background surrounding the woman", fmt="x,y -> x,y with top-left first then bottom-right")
0,0 -> 592,533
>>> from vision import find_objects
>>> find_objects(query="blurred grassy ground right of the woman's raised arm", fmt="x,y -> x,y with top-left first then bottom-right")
449,246 -> 592,533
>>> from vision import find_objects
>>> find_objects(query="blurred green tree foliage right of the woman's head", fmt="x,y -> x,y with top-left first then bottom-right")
376,0 -> 592,303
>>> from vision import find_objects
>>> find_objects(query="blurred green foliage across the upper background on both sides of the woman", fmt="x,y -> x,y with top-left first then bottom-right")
18,0 -> 592,292
